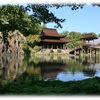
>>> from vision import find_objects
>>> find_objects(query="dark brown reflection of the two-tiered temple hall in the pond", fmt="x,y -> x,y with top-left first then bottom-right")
39,61 -> 67,80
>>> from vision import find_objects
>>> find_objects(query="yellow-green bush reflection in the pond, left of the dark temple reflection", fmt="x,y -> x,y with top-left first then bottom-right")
17,56 -> 41,81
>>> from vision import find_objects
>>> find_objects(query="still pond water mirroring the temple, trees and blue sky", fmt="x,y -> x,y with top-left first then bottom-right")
0,56 -> 100,84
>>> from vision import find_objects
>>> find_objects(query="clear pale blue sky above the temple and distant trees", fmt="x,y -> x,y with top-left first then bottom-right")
46,4 -> 100,34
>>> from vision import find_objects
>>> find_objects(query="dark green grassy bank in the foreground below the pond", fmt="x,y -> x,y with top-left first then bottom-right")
0,77 -> 100,95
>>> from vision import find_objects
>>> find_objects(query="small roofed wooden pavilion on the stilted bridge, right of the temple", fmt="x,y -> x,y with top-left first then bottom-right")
69,33 -> 98,55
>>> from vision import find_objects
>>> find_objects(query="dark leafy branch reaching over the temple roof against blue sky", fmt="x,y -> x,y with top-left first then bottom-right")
25,4 -> 65,28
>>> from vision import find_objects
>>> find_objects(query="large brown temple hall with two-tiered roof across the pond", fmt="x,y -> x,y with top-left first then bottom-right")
39,28 -> 69,49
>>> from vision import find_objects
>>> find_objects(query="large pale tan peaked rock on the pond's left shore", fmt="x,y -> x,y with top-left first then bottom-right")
8,30 -> 26,54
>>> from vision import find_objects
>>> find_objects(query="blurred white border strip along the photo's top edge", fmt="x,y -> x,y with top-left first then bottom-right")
0,0 -> 100,4
